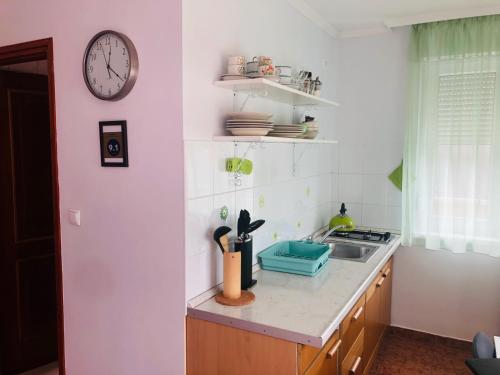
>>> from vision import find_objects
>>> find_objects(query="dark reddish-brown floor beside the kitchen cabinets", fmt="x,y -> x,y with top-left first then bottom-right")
370,327 -> 472,375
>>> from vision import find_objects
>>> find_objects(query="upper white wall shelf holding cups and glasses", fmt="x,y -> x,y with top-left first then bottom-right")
214,78 -> 339,107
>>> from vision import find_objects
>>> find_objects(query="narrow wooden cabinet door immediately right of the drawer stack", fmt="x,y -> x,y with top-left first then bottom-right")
364,273 -> 382,374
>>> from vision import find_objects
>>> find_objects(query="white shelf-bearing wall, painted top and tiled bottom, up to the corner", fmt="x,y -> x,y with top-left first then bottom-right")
183,0 -> 338,299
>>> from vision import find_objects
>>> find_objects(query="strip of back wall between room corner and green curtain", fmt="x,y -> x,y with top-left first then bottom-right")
337,30 -> 408,230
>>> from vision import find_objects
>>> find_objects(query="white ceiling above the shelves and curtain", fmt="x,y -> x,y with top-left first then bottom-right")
289,0 -> 500,37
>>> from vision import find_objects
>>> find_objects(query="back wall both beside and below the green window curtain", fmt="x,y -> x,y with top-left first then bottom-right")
338,28 -> 500,340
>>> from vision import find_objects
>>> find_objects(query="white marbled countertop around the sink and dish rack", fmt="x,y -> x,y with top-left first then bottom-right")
187,235 -> 400,348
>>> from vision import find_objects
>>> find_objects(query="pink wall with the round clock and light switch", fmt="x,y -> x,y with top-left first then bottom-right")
0,0 -> 184,375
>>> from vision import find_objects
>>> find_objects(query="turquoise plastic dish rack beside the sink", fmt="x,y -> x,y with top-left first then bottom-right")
258,241 -> 331,276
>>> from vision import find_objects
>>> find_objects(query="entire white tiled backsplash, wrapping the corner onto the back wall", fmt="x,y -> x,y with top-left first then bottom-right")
185,141 -> 401,299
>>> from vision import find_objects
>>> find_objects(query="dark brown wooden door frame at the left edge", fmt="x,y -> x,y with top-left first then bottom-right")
0,38 -> 66,375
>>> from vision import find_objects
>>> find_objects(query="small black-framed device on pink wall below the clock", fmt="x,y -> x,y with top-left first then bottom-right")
99,120 -> 128,167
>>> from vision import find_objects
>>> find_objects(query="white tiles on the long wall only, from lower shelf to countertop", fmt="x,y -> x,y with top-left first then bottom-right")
185,141 -> 337,299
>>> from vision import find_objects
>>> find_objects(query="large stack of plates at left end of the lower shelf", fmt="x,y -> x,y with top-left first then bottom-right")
226,112 -> 273,136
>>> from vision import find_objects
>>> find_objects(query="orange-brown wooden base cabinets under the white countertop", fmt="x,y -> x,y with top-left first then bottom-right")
186,258 -> 393,375
